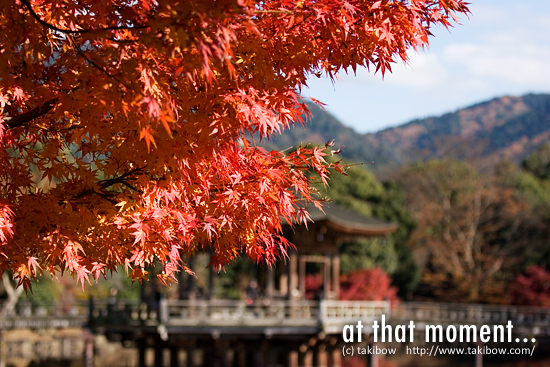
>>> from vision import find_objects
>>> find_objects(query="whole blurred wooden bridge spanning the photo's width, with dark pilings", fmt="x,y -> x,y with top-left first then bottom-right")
0,299 -> 550,367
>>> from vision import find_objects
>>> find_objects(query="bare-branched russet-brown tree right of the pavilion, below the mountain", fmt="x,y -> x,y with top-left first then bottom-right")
398,160 -> 526,302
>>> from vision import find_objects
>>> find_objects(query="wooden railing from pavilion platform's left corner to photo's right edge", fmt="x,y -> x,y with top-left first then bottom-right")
88,300 -> 550,333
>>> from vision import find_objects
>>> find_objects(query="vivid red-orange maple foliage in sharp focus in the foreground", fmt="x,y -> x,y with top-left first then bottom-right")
0,0 -> 468,286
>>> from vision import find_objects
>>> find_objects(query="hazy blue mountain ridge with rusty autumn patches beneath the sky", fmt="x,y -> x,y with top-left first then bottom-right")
265,94 -> 550,170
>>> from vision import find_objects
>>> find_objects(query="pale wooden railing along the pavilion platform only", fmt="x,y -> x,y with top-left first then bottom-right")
90,299 -> 389,332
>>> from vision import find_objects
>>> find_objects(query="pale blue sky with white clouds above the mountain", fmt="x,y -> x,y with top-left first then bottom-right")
302,0 -> 550,132
